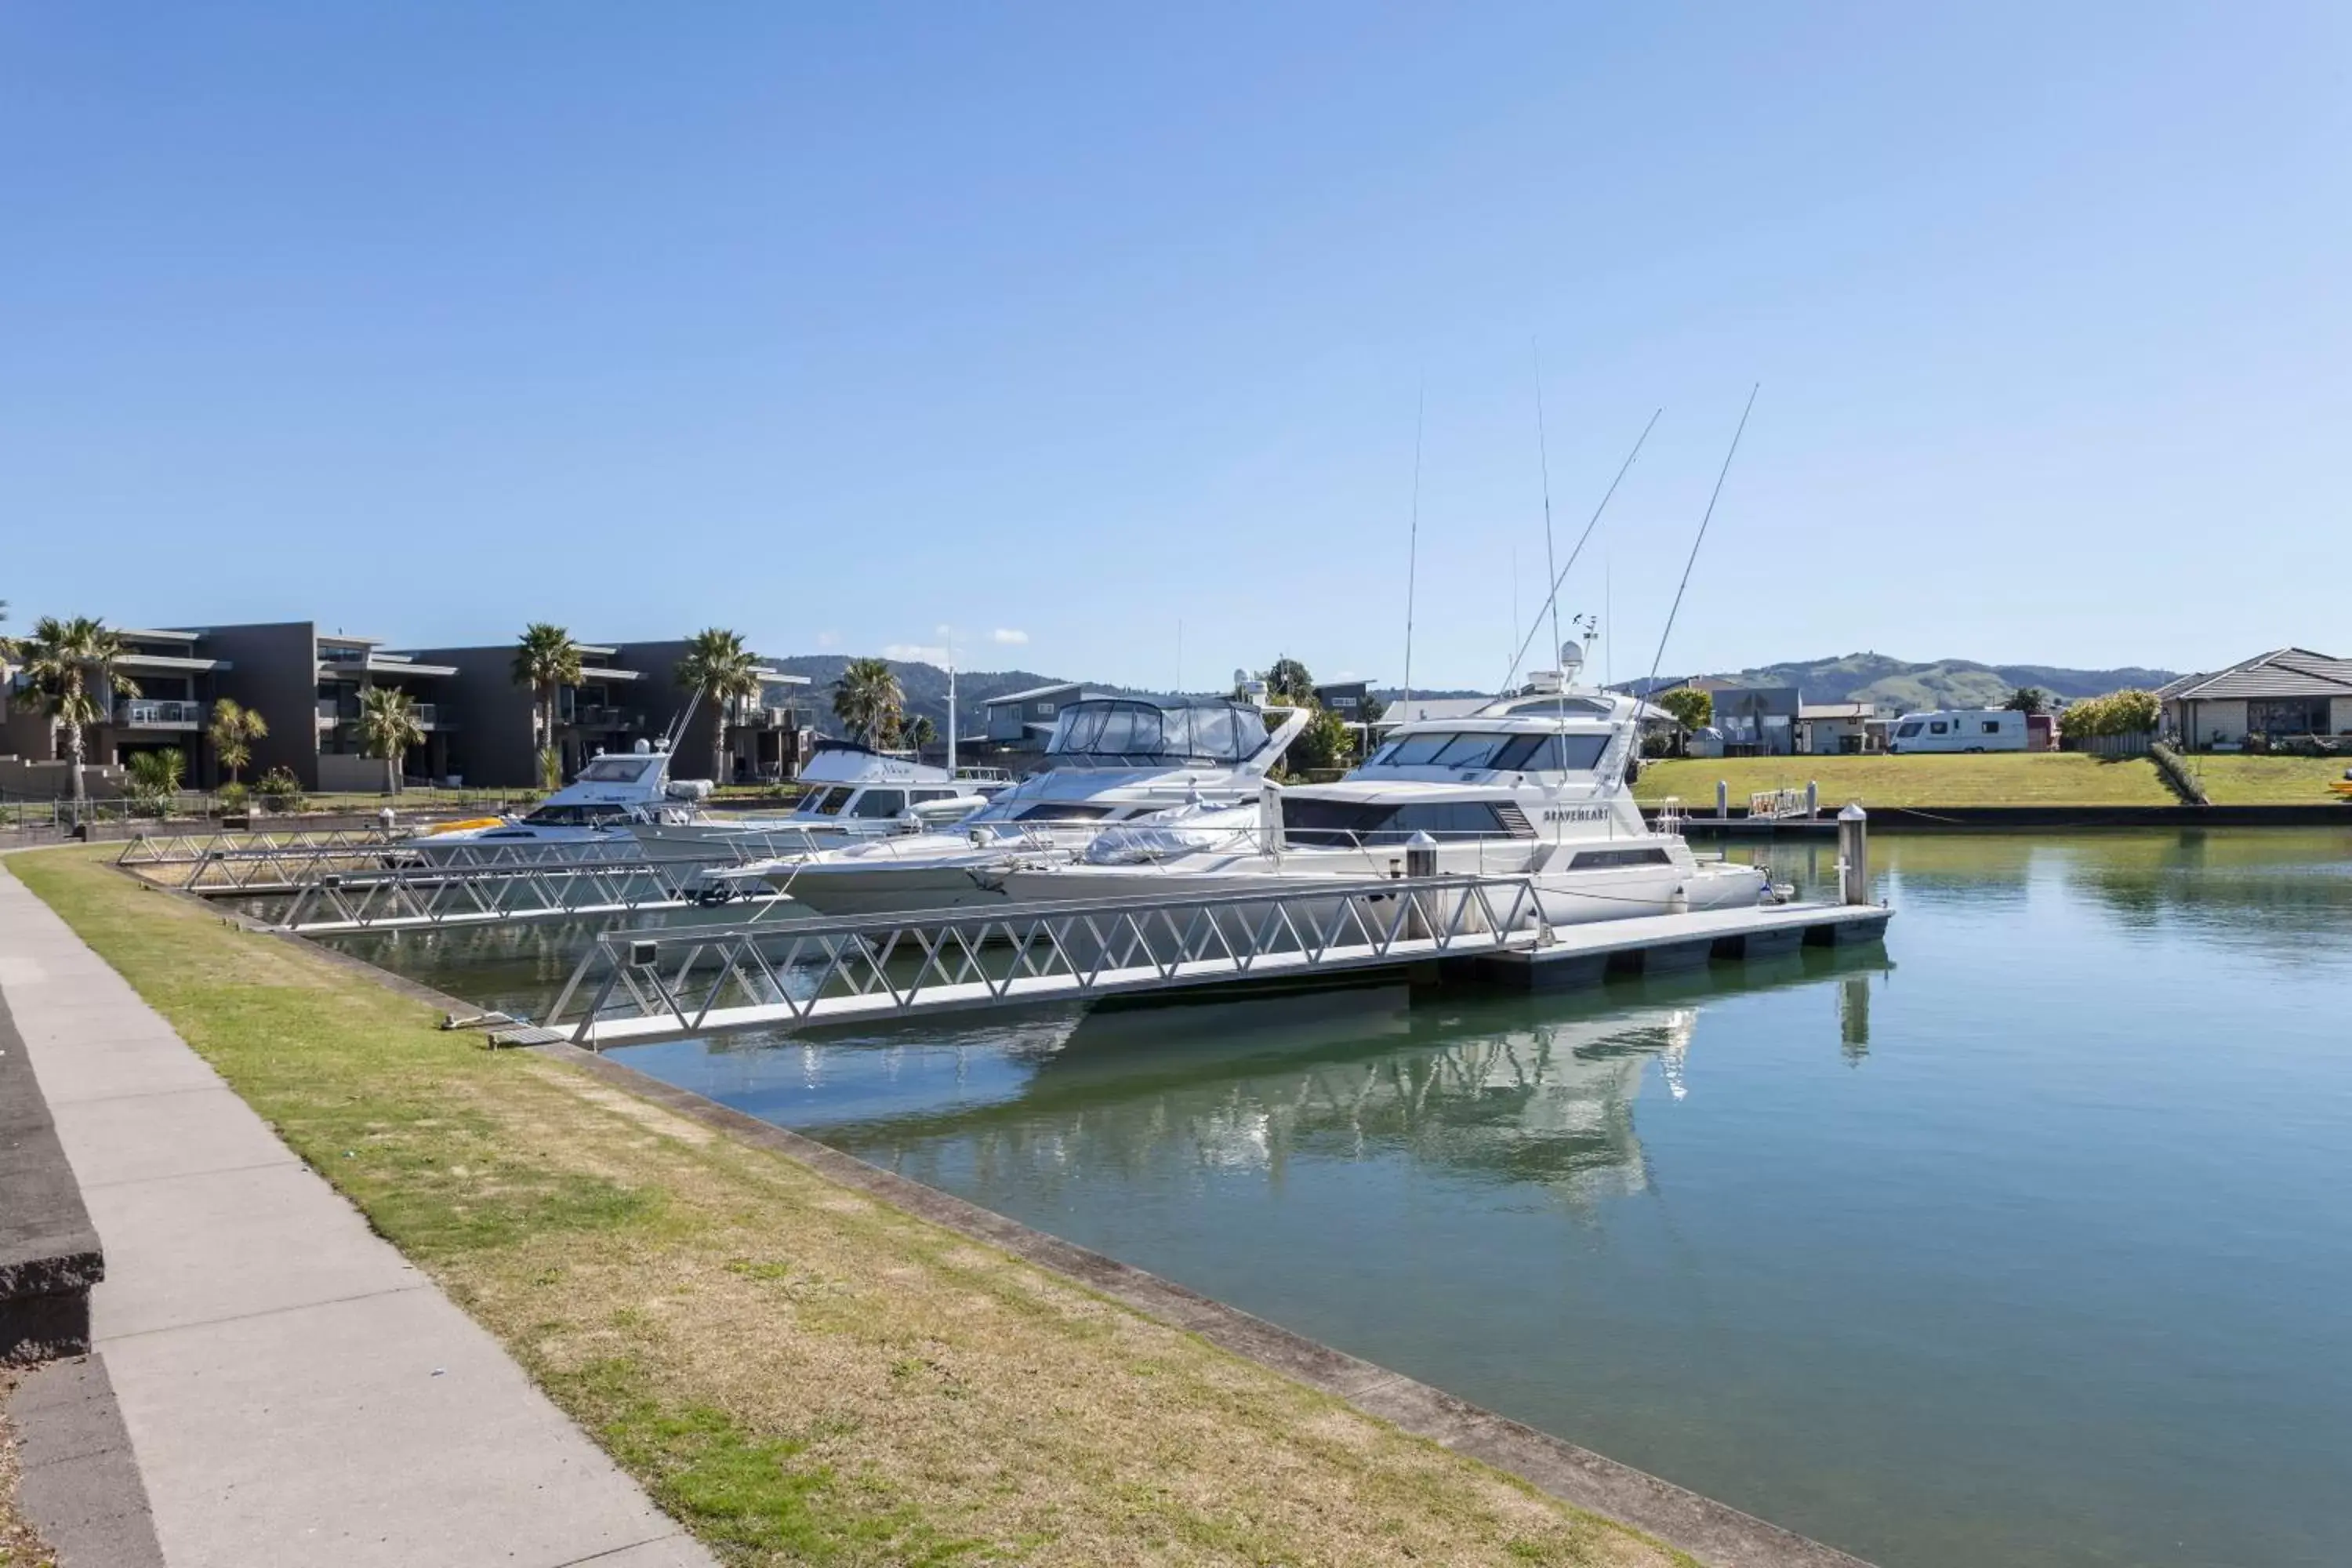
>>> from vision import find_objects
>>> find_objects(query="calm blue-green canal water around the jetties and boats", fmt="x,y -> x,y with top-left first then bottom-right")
336,829 -> 2352,1568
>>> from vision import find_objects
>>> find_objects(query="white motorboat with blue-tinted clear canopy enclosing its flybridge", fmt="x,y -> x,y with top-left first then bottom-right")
736,696 -> 1308,914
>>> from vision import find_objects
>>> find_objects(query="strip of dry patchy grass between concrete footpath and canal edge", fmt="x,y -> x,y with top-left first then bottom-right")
9,851 -> 1689,1568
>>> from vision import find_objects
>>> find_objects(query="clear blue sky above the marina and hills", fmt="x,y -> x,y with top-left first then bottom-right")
0,0 -> 2352,687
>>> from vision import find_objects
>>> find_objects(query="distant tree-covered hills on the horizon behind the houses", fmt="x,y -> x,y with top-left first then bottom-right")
771,654 -> 2176,736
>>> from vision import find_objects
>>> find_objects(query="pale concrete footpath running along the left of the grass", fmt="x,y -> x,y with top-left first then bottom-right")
0,865 -> 713,1568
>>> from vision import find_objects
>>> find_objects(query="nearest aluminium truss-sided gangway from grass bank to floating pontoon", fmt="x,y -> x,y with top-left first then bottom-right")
539,877 -> 1550,1046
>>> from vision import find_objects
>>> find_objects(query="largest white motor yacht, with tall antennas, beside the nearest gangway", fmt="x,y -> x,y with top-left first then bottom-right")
983,644 -> 1771,924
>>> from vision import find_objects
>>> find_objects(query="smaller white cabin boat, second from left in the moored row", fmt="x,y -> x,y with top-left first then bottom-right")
630,739 -> 1009,860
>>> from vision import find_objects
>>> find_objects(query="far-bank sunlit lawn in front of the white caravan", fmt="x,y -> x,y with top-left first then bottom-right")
1635,753 -> 2164,811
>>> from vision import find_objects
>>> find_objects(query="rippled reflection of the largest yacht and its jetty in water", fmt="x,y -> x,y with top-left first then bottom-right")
706,952 -> 1884,1215
